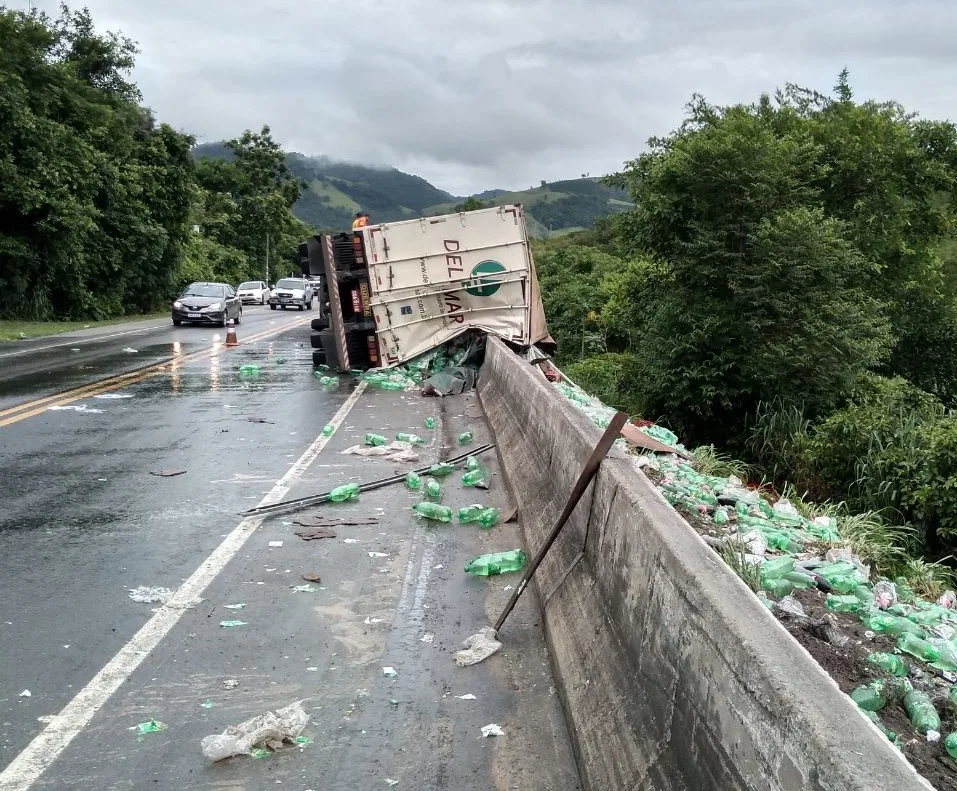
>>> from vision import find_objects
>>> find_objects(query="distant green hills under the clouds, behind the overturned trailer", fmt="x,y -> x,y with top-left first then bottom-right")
194,142 -> 631,237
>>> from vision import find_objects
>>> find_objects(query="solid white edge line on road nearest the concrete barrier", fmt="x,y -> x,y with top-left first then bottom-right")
0,382 -> 366,791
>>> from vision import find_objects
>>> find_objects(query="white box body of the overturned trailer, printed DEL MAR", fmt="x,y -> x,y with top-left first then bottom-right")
357,204 -> 548,367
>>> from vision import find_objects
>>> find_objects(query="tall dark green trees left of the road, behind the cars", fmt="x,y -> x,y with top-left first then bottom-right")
0,6 -> 314,319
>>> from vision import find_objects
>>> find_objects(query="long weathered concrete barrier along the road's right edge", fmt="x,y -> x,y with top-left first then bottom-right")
479,340 -> 931,791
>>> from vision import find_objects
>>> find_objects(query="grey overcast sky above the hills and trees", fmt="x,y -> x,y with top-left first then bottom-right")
26,0 -> 957,195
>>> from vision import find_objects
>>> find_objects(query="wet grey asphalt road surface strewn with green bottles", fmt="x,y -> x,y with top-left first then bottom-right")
0,307 -> 579,791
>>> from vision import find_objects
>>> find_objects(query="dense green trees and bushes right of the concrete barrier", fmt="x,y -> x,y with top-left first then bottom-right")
536,72 -> 957,580
